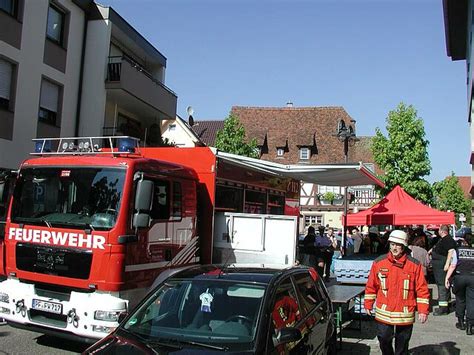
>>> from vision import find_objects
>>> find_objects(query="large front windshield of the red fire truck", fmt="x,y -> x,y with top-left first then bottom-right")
11,167 -> 125,230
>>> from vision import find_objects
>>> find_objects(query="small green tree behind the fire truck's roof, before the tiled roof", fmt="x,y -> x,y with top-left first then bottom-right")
216,114 -> 260,158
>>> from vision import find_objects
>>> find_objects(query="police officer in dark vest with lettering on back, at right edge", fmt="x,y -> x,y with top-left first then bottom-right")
445,246 -> 474,335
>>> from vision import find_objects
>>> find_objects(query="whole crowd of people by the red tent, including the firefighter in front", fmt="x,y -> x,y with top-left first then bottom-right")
300,225 -> 474,354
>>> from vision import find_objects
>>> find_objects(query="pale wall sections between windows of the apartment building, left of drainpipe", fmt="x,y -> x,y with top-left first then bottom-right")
0,0 -> 85,169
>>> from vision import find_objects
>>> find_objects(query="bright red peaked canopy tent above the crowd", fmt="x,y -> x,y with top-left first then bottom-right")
347,186 -> 455,226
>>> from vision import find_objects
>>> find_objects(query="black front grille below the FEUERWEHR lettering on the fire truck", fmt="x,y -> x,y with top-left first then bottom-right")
16,243 -> 92,280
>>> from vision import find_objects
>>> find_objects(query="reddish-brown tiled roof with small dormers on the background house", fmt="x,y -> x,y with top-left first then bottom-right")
231,106 -> 373,164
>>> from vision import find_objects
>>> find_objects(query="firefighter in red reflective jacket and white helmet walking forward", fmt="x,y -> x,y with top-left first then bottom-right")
364,230 -> 430,355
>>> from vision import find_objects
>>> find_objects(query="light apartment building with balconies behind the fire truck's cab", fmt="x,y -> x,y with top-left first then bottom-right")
0,0 -> 177,169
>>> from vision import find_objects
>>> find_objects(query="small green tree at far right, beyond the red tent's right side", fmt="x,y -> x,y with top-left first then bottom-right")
433,173 -> 471,227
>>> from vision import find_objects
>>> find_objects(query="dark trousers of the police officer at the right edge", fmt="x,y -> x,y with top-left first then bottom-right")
453,274 -> 474,324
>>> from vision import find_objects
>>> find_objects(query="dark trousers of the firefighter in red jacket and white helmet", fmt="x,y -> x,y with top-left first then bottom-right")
376,321 -> 413,355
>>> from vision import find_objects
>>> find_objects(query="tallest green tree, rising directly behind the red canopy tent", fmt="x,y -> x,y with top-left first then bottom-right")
371,102 -> 432,203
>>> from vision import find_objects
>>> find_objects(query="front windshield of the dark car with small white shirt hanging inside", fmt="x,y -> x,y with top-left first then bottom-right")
123,279 -> 265,350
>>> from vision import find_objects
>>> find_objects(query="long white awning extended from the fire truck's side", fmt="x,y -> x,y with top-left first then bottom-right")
216,151 -> 384,187
